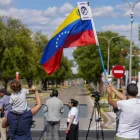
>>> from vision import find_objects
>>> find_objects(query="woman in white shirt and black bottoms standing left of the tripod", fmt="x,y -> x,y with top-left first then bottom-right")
66,99 -> 79,140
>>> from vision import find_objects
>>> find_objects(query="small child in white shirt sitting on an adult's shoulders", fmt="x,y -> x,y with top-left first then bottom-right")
9,80 -> 34,114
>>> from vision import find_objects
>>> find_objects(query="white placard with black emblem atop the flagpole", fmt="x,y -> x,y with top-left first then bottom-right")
78,2 -> 91,20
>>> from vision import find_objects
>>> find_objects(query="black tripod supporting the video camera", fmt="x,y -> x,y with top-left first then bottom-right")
86,98 -> 104,140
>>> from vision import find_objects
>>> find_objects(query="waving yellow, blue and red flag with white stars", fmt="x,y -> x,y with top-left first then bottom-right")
40,7 -> 96,74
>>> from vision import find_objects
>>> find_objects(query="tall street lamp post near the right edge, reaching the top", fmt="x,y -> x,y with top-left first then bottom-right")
124,0 -> 140,83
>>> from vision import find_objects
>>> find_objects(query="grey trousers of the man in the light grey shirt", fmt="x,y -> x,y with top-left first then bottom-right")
46,122 -> 60,140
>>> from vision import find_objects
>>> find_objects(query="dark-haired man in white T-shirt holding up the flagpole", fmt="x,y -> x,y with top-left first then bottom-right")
106,83 -> 140,140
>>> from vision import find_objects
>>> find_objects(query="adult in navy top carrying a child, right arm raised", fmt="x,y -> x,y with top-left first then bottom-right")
2,89 -> 42,140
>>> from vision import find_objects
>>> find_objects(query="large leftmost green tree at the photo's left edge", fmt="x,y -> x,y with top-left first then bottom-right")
0,17 -> 34,87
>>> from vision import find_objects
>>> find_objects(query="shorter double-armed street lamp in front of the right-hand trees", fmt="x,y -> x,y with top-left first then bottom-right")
98,36 -> 124,74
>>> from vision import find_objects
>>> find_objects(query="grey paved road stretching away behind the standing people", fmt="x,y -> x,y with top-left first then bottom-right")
28,84 -> 99,130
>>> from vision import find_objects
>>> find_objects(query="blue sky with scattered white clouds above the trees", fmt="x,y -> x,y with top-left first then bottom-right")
0,0 -> 140,73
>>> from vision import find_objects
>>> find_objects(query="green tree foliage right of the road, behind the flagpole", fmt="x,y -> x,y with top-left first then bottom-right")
73,31 -> 134,83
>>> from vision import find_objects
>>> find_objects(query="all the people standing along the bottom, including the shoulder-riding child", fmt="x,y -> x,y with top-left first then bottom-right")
0,80 -> 140,140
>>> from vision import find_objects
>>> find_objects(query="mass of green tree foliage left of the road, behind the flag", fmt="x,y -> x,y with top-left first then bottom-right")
0,17 -> 78,87
